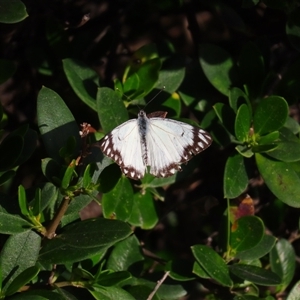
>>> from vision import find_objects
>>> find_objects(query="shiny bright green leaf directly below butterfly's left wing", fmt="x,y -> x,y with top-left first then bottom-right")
102,176 -> 133,221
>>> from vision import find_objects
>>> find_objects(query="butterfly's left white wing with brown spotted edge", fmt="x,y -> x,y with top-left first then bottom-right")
100,119 -> 146,180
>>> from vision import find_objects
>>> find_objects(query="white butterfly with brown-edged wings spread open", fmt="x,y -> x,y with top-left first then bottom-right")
100,110 -> 212,180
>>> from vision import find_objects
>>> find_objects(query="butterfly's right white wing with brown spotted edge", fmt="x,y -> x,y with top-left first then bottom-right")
145,118 -> 212,177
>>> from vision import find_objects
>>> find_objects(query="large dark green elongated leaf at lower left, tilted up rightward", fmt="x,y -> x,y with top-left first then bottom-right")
39,218 -> 131,264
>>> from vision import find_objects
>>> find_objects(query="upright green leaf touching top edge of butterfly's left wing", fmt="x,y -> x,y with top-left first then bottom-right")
97,88 -> 128,132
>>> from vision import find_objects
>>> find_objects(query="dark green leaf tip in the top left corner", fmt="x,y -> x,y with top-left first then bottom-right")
0,0 -> 28,24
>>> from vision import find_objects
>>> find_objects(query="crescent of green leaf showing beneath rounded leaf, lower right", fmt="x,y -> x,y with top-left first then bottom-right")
235,234 -> 276,261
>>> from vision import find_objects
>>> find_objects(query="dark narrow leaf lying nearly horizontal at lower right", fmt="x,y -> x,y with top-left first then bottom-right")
229,264 -> 281,286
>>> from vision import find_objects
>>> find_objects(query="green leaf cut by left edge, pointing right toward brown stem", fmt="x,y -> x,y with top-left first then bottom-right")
0,211 -> 32,234
